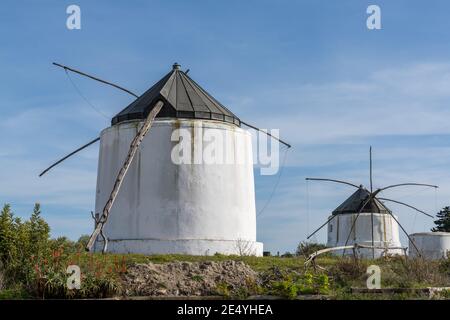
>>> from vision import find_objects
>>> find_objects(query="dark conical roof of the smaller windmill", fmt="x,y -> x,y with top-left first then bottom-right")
333,186 -> 390,215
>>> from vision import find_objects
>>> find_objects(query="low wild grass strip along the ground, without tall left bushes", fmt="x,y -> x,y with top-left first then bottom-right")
0,251 -> 450,299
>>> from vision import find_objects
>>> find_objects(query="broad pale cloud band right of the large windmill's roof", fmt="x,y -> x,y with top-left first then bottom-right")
230,63 -> 450,145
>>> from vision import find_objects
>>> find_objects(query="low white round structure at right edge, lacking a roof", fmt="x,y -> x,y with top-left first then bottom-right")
409,232 -> 450,259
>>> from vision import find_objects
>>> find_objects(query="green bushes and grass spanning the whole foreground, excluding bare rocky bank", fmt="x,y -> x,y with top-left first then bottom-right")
0,204 -> 450,299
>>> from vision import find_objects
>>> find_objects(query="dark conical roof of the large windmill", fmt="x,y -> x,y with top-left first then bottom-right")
111,63 -> 240,126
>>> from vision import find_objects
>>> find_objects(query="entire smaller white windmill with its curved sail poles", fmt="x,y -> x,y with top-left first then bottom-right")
306,147 -> 438,258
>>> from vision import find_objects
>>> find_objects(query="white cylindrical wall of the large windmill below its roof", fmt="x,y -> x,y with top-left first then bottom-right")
95,119 -> 262,255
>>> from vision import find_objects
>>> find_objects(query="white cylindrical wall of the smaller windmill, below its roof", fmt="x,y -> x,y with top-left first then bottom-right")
327,212 -> 403,258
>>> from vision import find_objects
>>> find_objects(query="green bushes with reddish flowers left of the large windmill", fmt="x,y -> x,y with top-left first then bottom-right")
0,204 -> 125,299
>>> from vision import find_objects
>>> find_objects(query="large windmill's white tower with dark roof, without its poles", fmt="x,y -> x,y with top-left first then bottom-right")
95,64 -> 263,255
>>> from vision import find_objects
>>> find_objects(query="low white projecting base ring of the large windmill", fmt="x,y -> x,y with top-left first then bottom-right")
94,239 -> 263,256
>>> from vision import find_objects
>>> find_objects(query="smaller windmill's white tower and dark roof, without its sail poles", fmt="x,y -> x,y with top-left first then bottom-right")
327,187 -> 404,258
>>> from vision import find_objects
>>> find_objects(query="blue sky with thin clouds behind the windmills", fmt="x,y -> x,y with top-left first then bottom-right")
0,0 -> 450,252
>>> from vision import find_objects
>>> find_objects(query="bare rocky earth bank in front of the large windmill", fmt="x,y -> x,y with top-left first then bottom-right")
122,260 -> 257,296
